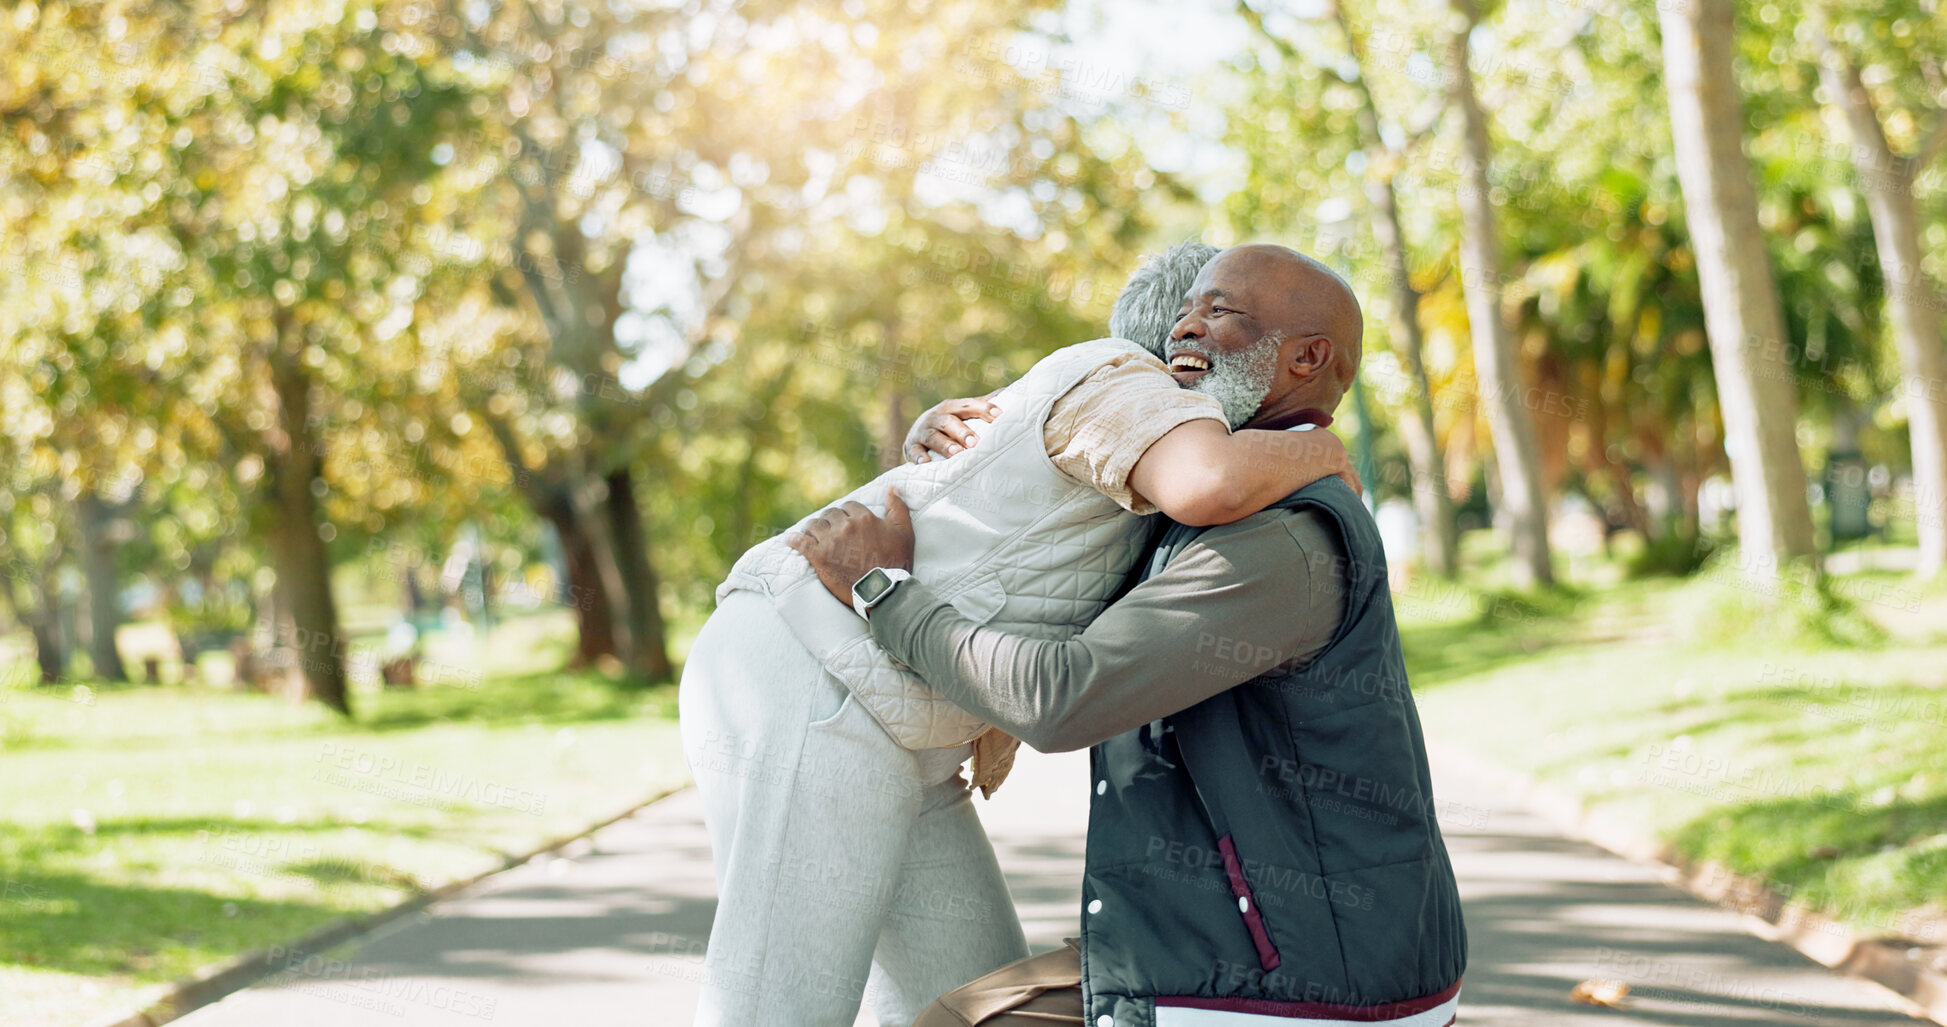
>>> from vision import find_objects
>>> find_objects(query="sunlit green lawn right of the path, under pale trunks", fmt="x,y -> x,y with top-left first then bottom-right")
1398,541 -> 1947,943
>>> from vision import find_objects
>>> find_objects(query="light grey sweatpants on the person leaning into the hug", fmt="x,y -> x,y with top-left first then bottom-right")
678,590 -> 1028,1027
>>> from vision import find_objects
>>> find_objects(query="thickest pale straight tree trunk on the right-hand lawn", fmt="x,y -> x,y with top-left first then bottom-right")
1657,0 -> 1817,579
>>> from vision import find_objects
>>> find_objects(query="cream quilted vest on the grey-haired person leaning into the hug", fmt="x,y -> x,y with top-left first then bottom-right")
716,339 -> 1147,748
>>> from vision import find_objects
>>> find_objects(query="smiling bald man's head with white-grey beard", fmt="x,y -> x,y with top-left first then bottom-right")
1168,244 -> 1365,427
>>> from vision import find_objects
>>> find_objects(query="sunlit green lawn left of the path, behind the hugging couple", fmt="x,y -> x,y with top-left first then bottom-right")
0,622 -> 685,1025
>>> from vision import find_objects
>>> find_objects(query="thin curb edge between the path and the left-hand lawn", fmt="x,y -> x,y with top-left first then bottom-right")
88,783 -> 689,1027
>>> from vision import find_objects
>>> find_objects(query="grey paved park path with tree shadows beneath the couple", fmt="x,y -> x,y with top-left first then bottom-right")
175,750 -> 1922,1027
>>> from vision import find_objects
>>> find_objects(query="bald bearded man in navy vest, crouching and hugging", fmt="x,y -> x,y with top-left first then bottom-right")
794,246 -> 1466,1027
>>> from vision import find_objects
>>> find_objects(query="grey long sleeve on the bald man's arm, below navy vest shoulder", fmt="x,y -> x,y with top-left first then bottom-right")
870,509 -> 1345,752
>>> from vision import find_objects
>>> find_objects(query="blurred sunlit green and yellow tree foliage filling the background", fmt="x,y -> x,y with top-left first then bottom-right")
0,0 -> 1947,697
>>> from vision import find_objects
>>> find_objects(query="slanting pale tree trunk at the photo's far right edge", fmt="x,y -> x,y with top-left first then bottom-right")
1820,45 -> 1947,577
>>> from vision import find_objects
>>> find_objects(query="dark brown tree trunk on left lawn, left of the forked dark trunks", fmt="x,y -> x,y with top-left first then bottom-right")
269,339 -> 352,717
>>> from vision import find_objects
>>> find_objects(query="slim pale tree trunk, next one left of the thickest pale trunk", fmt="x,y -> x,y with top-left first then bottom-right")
1447,0 -> 1556,587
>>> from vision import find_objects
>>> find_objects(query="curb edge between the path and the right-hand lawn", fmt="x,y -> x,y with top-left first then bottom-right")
1427,739 -> 1947,1025
